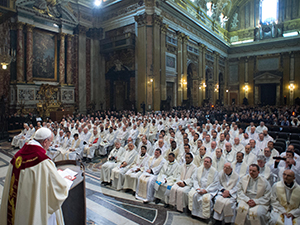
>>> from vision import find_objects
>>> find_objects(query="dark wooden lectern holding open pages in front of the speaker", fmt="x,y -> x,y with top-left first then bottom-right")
55,160 -> 86,225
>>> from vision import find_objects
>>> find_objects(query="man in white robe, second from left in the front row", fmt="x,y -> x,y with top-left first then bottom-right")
110,142 -> 137,190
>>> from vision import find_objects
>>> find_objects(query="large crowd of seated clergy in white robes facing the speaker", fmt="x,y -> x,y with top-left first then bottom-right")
12,114 -> 300,225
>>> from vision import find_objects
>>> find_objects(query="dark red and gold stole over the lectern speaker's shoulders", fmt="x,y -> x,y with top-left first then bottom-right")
7,143 -> 50,225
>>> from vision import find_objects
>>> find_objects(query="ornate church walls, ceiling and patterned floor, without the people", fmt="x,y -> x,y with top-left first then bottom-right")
0,0 -> 300,225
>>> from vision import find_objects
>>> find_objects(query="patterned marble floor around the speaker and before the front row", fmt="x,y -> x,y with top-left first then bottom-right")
0,142 -> 207,225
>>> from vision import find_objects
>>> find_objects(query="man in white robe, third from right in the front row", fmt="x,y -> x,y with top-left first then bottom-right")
213,163 -> 240,225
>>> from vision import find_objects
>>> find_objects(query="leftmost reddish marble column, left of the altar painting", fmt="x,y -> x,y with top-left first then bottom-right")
17,22 -> 25,83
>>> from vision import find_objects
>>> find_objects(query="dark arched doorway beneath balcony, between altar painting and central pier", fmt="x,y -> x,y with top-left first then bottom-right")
105,66 -> 135,110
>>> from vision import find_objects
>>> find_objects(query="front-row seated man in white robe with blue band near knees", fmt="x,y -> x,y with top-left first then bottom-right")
154,152 -> 180,208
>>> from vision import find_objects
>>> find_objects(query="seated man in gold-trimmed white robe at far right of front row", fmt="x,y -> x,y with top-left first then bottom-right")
269,169 -> 300,225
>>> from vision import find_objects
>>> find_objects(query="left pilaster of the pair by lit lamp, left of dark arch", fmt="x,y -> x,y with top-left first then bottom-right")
177,32 -> 184,106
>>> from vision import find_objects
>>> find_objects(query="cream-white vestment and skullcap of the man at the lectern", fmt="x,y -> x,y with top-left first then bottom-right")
0,140 -> 68,225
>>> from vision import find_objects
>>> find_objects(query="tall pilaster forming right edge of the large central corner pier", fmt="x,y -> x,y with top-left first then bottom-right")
153,14 -> 162,111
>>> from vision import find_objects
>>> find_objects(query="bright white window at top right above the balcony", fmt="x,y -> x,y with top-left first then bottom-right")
260,0 -> 278,24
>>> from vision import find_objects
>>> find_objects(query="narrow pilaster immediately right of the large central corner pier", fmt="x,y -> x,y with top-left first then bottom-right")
160,24 -> 168,100
